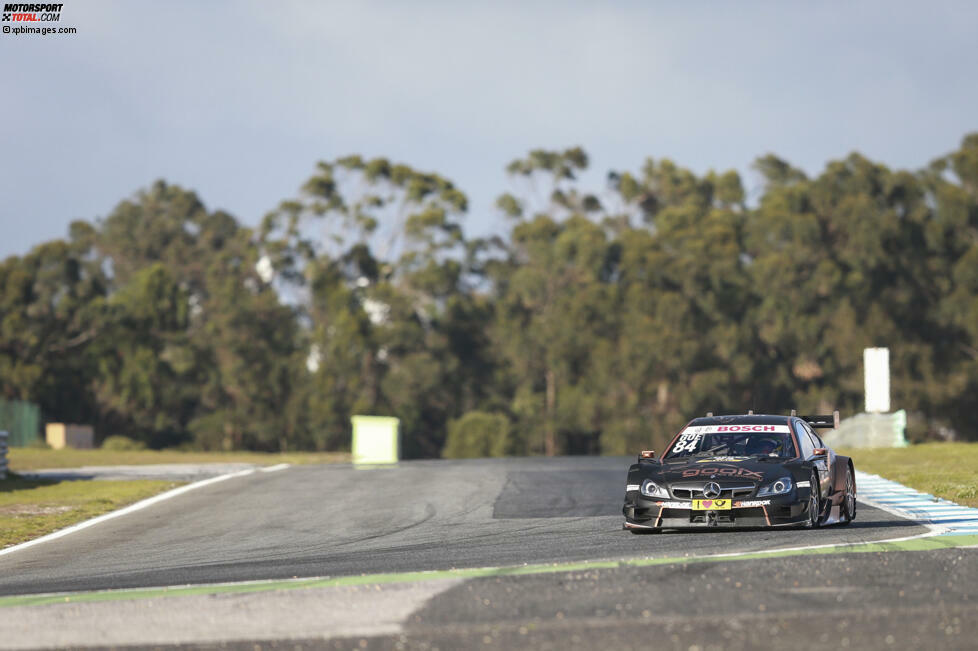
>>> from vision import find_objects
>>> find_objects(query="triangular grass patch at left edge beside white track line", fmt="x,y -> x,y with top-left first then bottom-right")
0,475 -> 181,549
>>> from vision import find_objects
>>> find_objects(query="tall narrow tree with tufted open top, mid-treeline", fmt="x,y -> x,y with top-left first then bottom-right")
490,147 -> 613,455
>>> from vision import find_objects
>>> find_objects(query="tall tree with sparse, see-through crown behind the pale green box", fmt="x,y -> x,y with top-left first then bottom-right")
261,156 -> 485,456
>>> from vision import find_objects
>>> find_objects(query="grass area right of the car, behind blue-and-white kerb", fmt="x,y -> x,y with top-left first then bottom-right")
839,443 -> 978,507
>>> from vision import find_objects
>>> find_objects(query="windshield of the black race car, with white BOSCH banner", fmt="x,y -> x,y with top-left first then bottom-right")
665,424 -> 795,459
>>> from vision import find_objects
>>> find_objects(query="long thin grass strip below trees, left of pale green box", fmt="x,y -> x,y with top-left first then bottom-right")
8,448 -> 350,472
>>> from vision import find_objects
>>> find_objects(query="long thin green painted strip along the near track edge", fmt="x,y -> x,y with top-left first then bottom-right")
0,535 -> 978,608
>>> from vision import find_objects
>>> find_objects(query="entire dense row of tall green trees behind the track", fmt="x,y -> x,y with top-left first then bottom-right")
0,134 -> 978,456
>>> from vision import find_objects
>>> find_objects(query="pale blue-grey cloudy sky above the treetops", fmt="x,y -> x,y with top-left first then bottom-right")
0,0 -> 978,257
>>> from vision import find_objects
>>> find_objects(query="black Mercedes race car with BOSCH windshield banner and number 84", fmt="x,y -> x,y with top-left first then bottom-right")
622,412 -> 856,533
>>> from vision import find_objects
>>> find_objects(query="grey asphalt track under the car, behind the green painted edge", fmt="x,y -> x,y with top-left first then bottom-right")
0,457 -> 924,594
